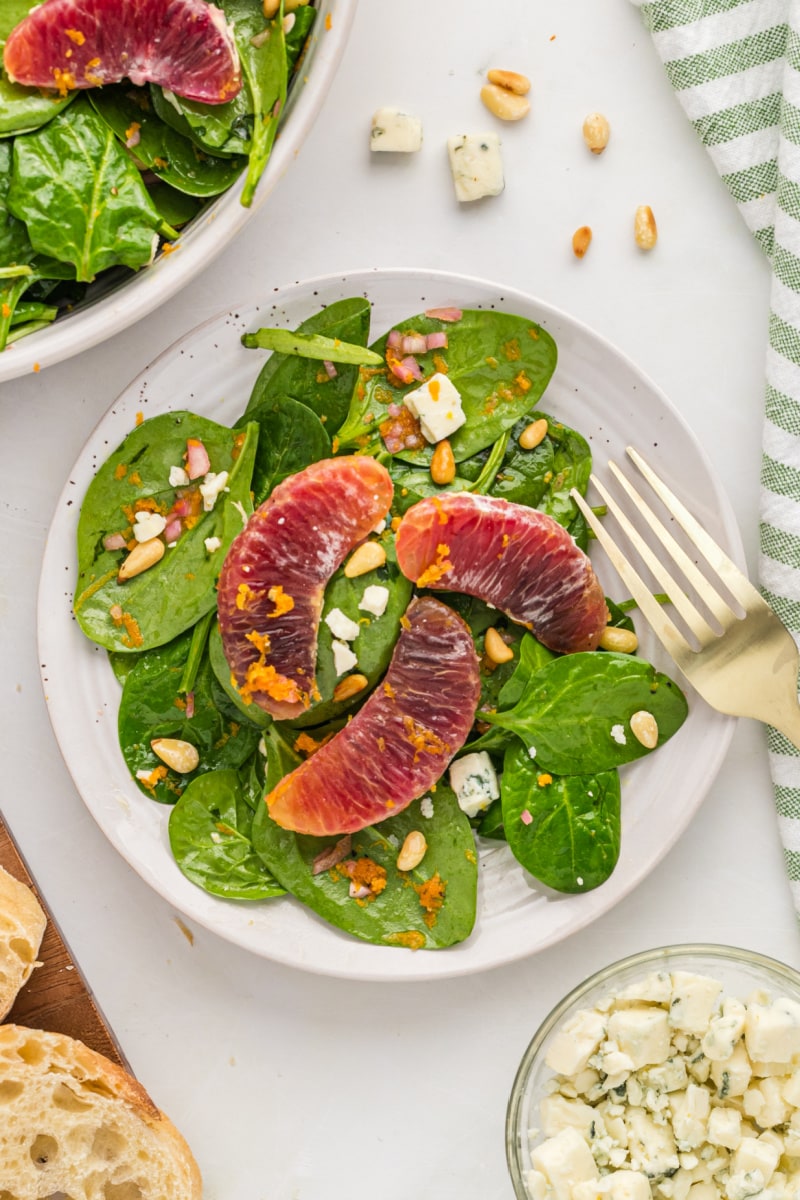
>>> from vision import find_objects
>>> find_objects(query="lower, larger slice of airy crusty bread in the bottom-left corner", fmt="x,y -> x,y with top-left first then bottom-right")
0,1025 -> 203,1200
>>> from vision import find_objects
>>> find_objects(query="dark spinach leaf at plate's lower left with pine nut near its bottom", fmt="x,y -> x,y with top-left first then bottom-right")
118,630 -> 260,804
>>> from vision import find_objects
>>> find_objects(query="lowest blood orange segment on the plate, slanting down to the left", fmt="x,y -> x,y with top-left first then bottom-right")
266,596 -> 481,836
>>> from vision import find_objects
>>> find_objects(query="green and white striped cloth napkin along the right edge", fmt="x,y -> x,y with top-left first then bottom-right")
633,0 -> 800,913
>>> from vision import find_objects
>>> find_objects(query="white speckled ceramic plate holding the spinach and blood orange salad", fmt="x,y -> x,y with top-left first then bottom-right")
38,269 -> 744,980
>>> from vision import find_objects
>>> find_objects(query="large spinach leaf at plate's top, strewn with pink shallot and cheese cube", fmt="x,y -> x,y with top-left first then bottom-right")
338,310 -> 557,463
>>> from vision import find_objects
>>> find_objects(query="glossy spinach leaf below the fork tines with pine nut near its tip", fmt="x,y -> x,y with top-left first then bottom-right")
481,652 -> 687,775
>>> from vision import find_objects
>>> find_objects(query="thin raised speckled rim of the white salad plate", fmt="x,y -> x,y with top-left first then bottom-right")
36,266 -> 746,984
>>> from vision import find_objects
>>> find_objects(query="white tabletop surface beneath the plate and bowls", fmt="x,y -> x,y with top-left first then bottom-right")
0,0 -> 800,1200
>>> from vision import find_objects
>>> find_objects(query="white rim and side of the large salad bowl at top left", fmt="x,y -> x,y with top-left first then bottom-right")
0,0 -> 357,383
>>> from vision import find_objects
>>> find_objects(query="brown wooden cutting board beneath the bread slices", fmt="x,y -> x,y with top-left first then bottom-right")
0,812 -> 131,1072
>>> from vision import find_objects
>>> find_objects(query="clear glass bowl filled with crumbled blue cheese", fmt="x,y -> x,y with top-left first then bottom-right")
506,946 -> 800,1200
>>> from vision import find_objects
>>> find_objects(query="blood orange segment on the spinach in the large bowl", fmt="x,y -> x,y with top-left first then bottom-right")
2,0 -> 241,104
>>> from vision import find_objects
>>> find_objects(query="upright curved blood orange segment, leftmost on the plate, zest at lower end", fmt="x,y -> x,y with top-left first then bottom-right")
217,456 -> 392,720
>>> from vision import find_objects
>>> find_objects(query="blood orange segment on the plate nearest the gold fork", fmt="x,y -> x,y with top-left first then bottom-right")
397,492 -> 608,654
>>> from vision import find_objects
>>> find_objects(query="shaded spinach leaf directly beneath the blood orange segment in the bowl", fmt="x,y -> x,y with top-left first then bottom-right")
88,84 -> 245,196
